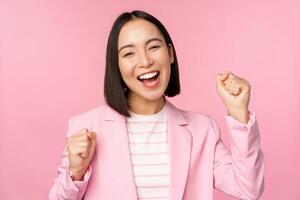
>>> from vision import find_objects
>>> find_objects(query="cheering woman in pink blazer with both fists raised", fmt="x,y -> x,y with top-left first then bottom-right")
49,11 -> 264,200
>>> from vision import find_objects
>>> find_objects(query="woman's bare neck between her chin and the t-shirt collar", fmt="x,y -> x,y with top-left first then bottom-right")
128,95 -> 165,115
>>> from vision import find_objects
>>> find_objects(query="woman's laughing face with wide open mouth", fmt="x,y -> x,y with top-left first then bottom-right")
118,19 -> 174,104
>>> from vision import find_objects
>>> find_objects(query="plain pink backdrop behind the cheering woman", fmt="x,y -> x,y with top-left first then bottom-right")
0,0 -> 300,200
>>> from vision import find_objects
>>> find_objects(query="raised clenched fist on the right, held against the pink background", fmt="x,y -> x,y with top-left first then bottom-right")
216,71 -> 251,123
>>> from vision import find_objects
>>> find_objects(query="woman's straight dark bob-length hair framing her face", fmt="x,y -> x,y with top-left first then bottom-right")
104,10 -> 180,117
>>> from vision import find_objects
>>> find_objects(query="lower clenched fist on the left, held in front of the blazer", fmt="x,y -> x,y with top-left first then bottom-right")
67,129 -> 97,180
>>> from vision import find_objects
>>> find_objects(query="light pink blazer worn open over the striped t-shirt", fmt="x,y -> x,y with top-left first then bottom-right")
49,101 -> 264,200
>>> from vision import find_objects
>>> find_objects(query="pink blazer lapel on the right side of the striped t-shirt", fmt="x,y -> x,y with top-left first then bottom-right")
166,101 -> 192,200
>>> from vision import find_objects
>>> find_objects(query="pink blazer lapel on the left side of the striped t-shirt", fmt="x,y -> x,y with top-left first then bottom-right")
102,106 -> 137,200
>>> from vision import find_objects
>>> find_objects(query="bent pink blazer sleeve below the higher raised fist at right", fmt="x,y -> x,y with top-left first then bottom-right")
213,112 -> 264,200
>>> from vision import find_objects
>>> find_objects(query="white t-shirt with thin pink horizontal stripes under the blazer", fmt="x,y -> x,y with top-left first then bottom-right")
127,107 -> 170,200
